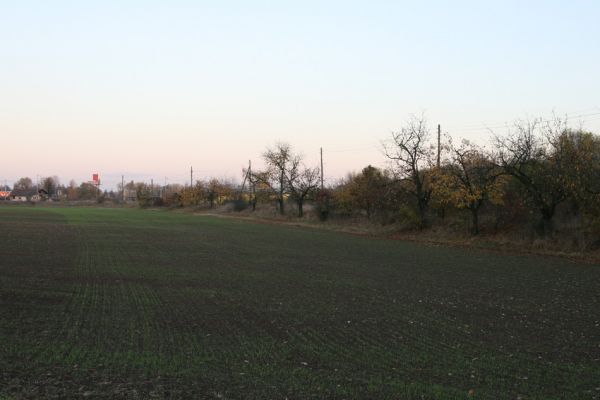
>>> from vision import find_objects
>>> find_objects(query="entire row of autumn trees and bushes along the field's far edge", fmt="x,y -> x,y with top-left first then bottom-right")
8,116 -> 600,246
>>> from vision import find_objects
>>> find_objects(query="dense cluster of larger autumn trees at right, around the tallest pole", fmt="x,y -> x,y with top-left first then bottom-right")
332,117 -> 600,242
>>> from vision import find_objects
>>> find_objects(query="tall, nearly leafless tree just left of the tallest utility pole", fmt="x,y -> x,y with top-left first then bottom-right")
383,115 -> 432,227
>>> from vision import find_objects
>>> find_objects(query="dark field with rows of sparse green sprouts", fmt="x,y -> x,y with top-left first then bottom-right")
0,207 -> 600,399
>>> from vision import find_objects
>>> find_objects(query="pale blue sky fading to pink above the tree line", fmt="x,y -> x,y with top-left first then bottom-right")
0,0 -> 600,189
